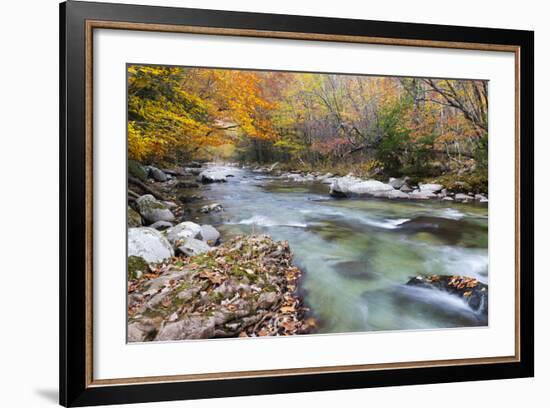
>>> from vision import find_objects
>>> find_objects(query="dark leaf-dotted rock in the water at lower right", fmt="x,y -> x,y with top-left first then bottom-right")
407,275 -> 489,314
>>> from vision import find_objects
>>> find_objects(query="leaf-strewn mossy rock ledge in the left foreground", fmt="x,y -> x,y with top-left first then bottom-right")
128,235 -> 316,342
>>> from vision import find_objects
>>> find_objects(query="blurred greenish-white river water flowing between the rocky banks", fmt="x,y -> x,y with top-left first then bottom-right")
182,168 -> 488,333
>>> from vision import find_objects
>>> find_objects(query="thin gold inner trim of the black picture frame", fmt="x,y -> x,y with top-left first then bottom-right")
85,20 -> 521,388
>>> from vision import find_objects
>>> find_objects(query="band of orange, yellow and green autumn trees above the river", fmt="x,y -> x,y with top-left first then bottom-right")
128,65 -> 488,182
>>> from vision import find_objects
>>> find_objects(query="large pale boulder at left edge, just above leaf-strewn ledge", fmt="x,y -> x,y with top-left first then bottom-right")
128,227 -> 174,263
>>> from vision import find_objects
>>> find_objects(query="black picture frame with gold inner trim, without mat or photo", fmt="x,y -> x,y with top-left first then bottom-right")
60,1 -> 534,406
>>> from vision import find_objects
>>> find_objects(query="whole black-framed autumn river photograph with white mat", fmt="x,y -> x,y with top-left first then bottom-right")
60,1 -> 534,406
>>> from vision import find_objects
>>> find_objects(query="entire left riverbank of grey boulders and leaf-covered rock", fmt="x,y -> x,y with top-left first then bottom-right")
128,163 -> 316,342
